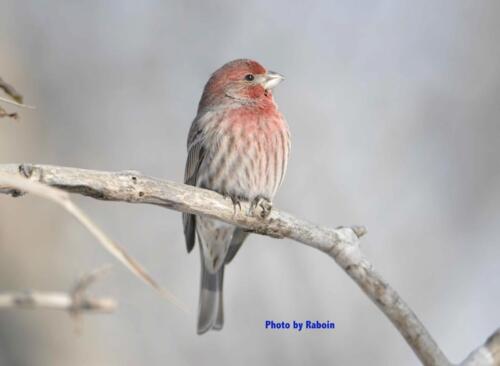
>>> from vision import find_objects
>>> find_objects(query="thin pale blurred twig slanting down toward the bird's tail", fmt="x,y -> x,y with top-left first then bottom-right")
0,170 -> 189,312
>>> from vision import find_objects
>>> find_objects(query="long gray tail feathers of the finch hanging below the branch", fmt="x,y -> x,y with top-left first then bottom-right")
198,258 -> 224,334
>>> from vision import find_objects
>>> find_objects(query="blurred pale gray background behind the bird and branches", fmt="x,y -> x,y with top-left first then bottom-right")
0,0 -> 500,366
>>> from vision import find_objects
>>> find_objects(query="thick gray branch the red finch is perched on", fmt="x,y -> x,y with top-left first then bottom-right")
0,164 -> 494,365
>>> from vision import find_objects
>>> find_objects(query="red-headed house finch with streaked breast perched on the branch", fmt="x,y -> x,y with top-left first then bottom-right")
182,60 -> 290,334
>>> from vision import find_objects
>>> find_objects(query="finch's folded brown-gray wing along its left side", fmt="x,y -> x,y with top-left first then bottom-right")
182,121 -> 205,253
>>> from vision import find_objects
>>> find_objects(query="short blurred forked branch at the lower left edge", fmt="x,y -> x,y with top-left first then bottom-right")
0,270 -> 117,316
